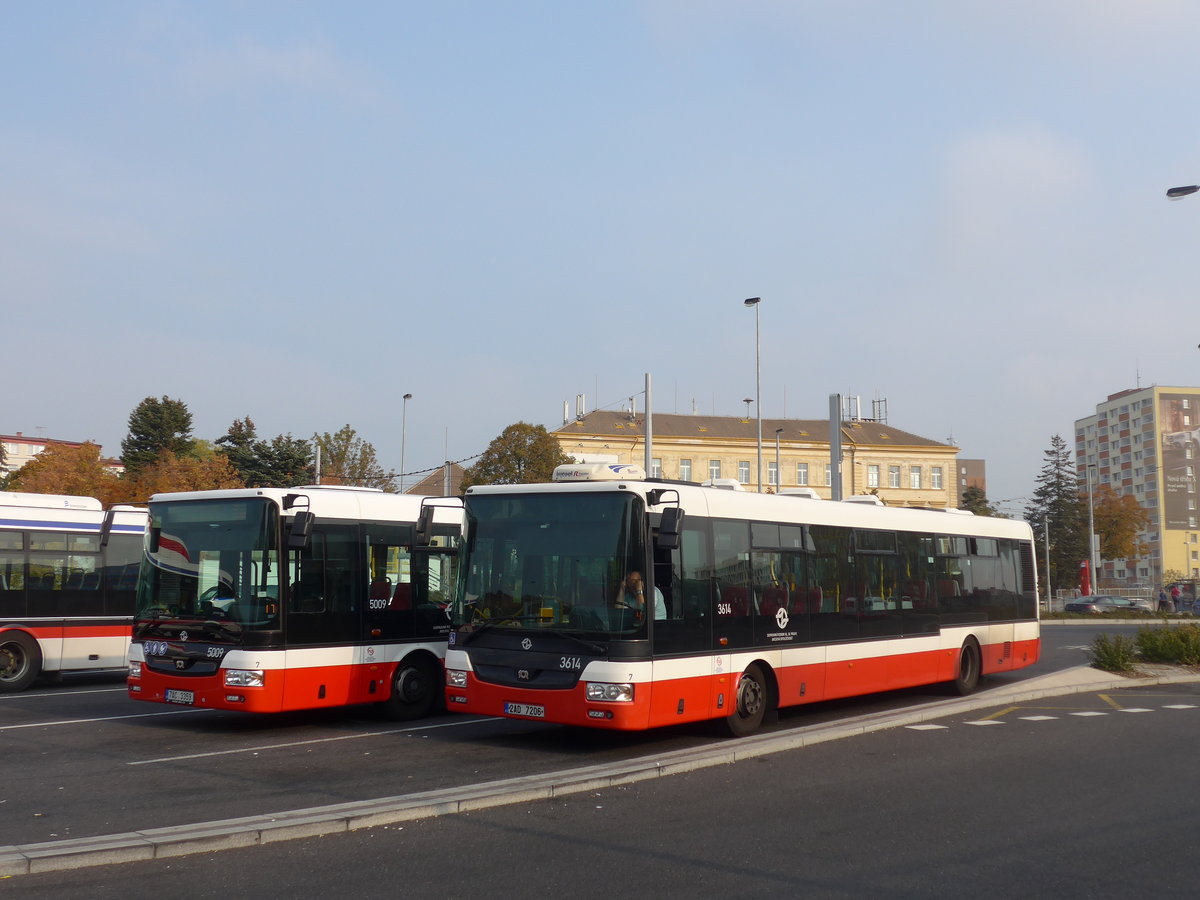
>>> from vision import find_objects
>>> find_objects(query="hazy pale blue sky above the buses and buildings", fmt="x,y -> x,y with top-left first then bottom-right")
7,0 -> 1200,511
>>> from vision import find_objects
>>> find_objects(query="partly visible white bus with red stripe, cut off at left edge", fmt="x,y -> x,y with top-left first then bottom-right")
0,493 -> 146,691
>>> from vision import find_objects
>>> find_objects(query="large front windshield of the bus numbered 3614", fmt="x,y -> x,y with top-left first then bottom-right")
451,491 -> 647,638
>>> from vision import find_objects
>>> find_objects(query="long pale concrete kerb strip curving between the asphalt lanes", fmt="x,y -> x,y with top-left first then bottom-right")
0,666 -> 1200,876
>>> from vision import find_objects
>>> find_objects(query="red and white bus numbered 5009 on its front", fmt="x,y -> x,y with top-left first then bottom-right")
128,486 -> 462,719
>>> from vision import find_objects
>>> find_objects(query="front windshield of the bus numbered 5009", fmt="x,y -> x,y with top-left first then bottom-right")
137,497 -> 280,637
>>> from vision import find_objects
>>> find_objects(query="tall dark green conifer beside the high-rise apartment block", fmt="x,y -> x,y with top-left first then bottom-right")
1025,434 -> 1087,590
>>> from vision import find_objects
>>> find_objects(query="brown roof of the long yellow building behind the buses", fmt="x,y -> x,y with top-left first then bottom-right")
554,409 -> 958,450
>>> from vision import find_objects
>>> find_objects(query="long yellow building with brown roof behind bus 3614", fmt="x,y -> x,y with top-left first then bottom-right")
553,410 -> 959,509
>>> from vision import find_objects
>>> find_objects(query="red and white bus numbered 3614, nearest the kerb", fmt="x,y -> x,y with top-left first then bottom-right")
445,466 -> 1039,734
